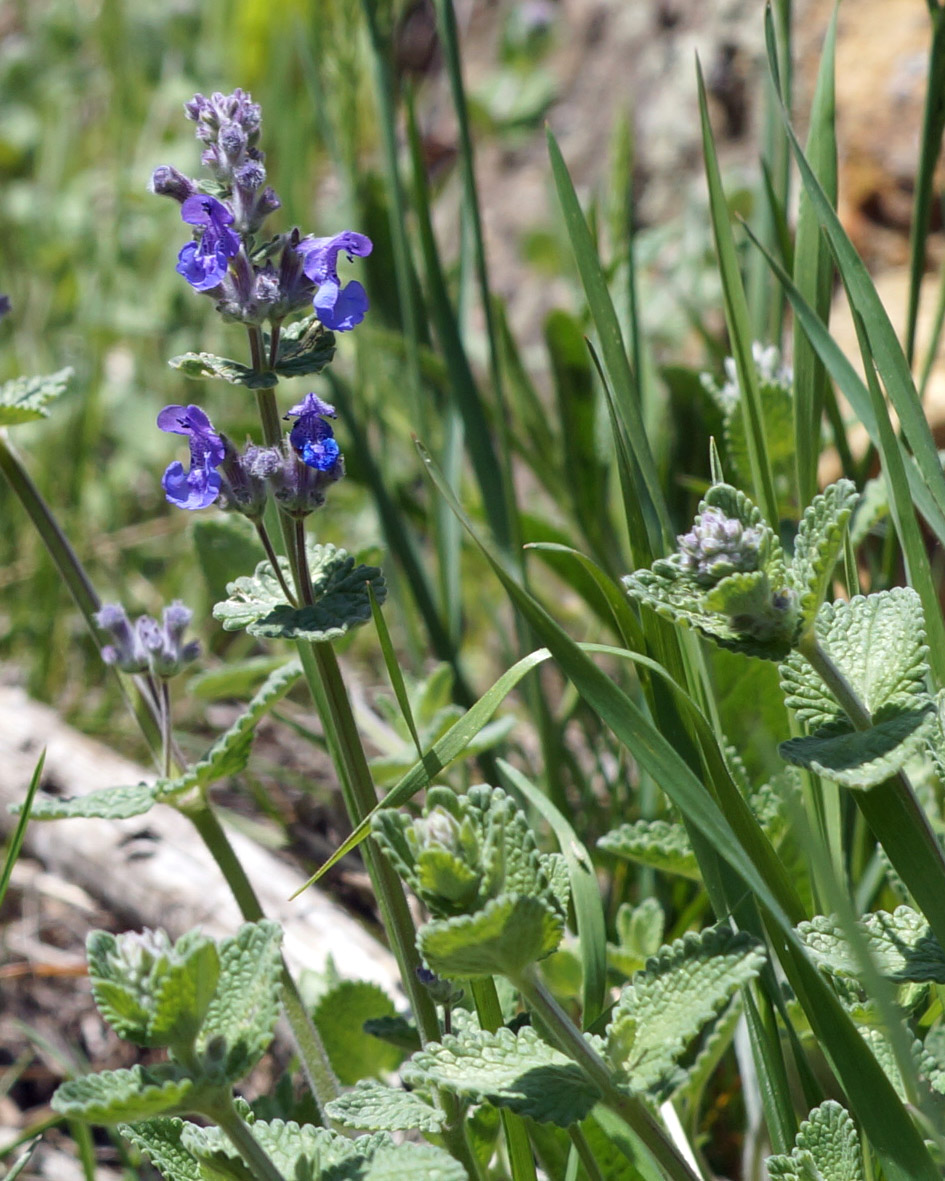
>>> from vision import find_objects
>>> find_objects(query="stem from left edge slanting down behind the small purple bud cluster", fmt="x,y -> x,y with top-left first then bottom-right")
0,430 -> 162,753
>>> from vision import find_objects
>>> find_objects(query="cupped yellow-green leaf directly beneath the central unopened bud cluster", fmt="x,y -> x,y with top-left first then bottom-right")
417,894 -> 565,978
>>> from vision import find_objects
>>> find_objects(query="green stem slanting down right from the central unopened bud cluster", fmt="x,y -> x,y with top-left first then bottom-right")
511,965 -> 699,1181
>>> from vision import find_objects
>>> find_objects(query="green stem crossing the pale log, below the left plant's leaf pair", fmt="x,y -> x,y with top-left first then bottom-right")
181,801 -> 341,1110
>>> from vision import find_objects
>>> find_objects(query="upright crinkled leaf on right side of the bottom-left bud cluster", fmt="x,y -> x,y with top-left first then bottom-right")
197,919 -> 282,1082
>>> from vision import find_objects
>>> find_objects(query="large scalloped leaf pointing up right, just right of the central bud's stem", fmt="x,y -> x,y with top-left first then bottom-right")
607,926 -> 764,1101
